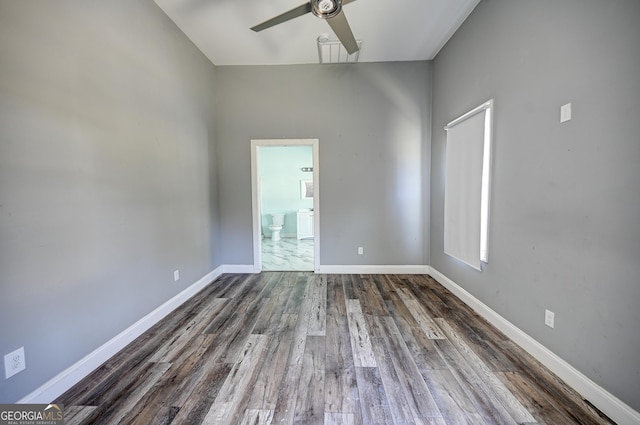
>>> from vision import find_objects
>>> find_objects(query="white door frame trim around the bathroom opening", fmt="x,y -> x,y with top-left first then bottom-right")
251,139 -> 320,273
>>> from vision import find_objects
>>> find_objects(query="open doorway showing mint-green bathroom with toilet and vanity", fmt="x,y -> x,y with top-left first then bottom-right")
251,139 -> 320,272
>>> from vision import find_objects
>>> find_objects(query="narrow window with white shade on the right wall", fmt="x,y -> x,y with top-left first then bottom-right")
444,99 -> 493,270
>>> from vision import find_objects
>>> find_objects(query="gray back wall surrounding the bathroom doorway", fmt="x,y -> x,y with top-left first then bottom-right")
216,62 -> 431,265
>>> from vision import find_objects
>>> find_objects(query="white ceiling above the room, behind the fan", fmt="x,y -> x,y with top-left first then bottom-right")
155,0 -> 480,65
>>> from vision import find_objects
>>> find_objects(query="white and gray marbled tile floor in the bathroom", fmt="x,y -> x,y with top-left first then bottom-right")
262,238 -> 314,271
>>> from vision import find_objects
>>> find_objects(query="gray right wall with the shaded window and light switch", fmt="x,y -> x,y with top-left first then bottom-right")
431,0 -> 640,411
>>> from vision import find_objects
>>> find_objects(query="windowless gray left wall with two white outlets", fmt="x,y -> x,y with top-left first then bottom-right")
0,0 -> 220,403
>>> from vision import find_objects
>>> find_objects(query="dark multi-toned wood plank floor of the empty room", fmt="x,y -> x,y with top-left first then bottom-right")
57,272 -> 611,425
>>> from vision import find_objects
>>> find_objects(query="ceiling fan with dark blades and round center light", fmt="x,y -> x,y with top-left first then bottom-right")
251,0 -> 358,55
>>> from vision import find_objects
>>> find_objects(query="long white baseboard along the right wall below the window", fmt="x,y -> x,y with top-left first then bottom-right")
427,266 -> 640,425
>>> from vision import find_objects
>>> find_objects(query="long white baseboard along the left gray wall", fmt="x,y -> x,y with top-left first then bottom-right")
18,267 -> 223,404
